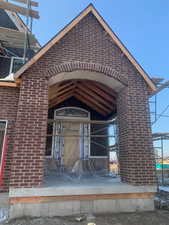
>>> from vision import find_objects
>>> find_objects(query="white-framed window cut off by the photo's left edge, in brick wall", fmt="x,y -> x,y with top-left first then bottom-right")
0,120 -> 7,167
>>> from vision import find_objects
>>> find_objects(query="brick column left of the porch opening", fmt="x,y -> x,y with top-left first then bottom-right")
10,76 -> 48,187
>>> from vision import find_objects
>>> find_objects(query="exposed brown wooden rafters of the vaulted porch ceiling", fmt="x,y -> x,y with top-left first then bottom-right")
49,80 -> 117,116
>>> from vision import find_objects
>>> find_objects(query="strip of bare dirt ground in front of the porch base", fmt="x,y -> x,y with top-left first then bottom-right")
0,210 -> 169,225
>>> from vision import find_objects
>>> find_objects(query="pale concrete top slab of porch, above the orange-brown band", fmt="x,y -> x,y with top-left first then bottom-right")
9,179 -> 157,198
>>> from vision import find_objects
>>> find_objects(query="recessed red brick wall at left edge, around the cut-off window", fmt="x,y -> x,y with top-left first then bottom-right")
0,87 -> 19,192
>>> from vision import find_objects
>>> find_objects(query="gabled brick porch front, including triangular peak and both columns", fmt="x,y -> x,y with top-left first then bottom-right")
6,13 -> 155,187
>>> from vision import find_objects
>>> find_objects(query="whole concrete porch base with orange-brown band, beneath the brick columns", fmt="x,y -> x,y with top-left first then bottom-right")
9,179 -> 156,218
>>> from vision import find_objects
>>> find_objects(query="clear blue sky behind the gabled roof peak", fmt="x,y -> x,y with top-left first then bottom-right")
29,0 -> 169,153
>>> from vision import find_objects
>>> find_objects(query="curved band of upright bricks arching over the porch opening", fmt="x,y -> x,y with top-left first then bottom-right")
47,61 -> 127,86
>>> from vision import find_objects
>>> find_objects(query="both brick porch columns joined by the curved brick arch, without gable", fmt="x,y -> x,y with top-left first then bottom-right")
11,62 -> 155,187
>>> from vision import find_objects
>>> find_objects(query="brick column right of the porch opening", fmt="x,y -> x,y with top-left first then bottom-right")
117,79 -> 155,185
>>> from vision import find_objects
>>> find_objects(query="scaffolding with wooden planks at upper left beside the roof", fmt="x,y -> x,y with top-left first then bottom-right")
0,0 -> 40,75
